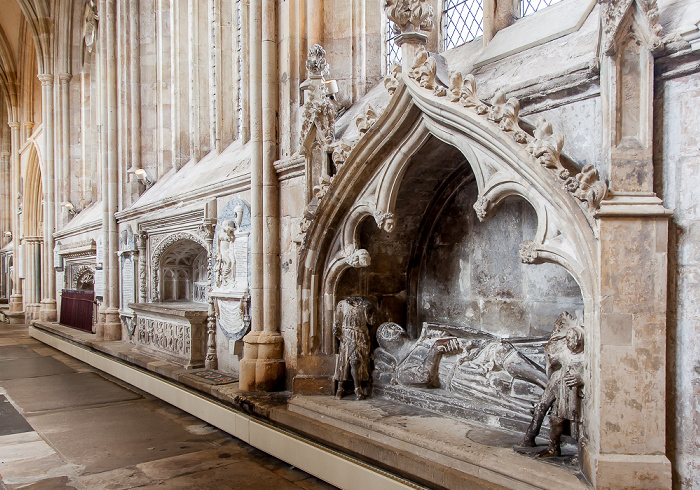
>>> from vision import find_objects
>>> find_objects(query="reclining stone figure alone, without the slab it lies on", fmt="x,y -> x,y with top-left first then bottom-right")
374,322 -> 547,397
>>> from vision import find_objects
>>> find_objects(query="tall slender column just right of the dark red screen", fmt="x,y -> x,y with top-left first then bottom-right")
102,0 -> 122,340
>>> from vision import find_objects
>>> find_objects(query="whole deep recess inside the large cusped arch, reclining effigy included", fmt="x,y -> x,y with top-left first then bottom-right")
335,138 -> 583,434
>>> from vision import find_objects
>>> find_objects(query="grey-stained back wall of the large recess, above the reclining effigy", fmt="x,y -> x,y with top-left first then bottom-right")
418,183 -> 583,337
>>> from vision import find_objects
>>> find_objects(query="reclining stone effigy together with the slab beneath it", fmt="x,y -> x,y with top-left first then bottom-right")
372,322 -> 547,427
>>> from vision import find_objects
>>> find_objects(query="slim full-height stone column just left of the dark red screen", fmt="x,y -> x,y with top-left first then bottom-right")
39,73 -> 58,322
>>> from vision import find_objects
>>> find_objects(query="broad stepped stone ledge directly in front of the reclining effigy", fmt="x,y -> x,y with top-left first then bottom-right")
271,396 -> 590,489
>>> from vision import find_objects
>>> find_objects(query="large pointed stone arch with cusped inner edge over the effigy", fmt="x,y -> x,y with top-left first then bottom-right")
298,78 -> 599,374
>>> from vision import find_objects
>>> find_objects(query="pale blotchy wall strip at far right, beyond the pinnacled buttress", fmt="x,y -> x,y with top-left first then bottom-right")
654,71 -> 700,488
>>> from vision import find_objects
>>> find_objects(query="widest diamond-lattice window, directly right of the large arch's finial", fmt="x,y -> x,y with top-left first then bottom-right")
442,0 -> 482,50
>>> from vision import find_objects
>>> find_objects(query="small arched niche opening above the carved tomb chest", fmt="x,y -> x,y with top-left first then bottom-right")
160,239 -> 208,303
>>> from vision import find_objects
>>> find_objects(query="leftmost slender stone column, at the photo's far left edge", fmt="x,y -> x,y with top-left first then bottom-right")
8,121 -> 24,323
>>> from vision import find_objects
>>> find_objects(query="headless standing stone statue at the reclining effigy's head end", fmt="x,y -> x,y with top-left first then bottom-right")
333,296 -> 374,400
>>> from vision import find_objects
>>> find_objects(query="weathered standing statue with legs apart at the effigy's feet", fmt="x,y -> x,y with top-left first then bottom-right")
519,312 -> 584,458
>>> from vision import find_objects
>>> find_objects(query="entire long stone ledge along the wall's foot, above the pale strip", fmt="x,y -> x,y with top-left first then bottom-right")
30,322 -> 590,489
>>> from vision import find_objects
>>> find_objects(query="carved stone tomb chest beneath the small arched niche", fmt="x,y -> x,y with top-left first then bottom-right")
129,303 -> 207,369
